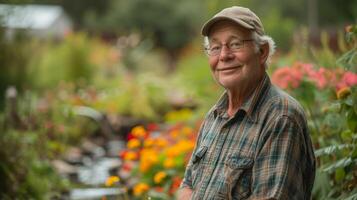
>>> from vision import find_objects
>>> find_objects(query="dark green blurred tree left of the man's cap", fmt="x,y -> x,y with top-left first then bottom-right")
88,0 -> 205,71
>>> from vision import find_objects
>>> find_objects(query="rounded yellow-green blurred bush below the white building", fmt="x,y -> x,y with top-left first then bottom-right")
29,33 -> 93,89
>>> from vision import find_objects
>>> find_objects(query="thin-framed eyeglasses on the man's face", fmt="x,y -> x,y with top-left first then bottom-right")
205,39 -> 254,56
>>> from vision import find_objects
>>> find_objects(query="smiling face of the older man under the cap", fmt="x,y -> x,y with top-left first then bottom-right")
208,21 -> 265,91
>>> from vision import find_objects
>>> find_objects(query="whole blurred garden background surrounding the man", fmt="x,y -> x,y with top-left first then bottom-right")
0,0 -> 357,200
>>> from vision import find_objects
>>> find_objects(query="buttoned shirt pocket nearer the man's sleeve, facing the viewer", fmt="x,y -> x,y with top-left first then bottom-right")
221,156 -> 254,200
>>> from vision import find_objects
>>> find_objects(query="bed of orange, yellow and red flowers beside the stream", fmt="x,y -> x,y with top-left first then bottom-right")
106,123 -> 198,199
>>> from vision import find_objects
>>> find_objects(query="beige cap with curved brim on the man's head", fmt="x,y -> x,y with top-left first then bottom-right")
201,6 -> 264,36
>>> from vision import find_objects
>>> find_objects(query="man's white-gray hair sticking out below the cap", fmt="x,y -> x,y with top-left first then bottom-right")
203,32 -> 276,68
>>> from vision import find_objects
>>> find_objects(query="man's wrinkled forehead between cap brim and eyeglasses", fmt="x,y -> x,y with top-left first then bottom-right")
208,20 -> 253,40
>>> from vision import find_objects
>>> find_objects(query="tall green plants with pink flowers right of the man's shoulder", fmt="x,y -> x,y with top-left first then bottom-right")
272,26 -> 357,199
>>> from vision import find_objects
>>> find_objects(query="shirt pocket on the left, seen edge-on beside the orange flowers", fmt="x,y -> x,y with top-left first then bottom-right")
192,146 -> 208,188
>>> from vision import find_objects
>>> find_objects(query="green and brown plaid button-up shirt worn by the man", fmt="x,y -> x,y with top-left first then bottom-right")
181,75 -> 316,200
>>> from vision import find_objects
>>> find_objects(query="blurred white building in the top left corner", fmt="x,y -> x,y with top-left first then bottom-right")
0,4 -> 73,38
